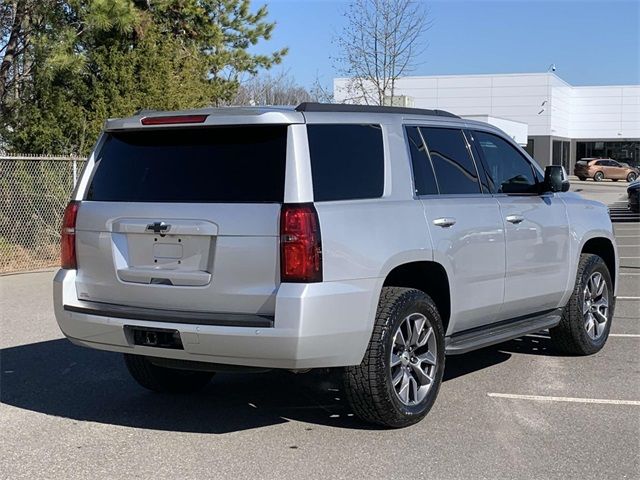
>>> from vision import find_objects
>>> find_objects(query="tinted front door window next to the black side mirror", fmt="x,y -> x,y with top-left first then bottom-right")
473,131 -> 537,193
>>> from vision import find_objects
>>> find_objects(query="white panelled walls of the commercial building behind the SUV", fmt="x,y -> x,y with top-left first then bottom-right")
334,72 -> 640,171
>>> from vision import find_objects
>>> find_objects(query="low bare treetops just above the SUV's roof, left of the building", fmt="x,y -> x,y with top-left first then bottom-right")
231,72 -> 315,105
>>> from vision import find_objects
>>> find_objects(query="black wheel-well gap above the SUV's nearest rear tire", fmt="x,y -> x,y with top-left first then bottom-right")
382,260 -> 451,333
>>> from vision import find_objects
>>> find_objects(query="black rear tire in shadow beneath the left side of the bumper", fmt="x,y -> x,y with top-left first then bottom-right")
124,353 -> 214,393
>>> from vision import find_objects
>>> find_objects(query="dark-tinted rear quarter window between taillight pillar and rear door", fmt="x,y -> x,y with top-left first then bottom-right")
307,125 -> 384,202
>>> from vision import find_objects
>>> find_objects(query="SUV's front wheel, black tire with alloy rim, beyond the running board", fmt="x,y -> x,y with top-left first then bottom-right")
549,254 -> 615,355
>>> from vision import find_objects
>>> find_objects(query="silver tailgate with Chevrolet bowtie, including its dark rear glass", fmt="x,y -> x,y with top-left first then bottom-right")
76,125 -> 287,315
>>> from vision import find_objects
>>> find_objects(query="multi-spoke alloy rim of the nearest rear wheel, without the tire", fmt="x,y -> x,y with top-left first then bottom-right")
389,313 -> 438,406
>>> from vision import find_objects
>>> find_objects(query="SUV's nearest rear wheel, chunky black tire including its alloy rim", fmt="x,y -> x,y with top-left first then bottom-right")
344,287 -> 444,428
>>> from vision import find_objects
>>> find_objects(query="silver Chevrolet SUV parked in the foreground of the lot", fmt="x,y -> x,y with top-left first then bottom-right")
54,103 -> 618,427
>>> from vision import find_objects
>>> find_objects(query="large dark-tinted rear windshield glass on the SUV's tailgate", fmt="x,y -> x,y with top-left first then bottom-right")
86,125 -> 287,203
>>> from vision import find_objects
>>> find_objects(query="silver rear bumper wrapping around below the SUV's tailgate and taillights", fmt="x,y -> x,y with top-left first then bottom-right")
53,270 -> 382,369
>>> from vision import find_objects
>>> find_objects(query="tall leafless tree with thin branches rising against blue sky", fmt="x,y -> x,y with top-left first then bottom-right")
335,0 -> 431,105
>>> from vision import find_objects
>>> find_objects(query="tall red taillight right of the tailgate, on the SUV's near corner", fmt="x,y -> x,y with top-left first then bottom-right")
280,203 -> 322,283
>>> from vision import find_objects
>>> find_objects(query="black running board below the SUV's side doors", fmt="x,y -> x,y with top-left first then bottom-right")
445,308 -> 562,355
